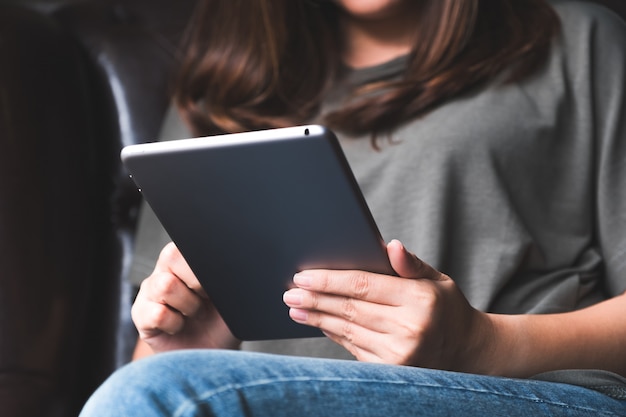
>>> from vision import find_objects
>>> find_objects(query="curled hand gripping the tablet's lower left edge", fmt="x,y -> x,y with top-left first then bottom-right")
131,243 -> 240,353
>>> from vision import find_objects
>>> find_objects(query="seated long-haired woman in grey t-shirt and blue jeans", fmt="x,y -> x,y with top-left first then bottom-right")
83,0 -> 626,416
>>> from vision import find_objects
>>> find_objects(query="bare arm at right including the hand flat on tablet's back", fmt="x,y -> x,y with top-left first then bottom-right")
284,237 -> 626,377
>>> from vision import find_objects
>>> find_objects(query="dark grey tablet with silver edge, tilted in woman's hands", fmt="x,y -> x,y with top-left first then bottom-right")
121,125 -> 393,340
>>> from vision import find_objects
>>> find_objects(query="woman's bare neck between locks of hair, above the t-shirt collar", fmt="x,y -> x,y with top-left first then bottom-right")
342,11 -> 415,68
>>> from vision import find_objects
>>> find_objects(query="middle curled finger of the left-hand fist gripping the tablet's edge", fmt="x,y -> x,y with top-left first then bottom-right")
141,273 -> 204,317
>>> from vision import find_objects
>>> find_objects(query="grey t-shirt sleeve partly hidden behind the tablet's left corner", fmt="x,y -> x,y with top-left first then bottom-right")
128,106 -> 192,286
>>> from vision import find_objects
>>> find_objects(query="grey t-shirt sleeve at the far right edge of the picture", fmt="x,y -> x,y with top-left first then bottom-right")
591,4 -> 626,296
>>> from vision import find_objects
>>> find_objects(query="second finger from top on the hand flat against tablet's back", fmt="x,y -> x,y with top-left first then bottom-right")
283,288 -> 398,333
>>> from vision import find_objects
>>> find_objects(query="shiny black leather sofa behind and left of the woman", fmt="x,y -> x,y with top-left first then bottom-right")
0,0 -> 626,417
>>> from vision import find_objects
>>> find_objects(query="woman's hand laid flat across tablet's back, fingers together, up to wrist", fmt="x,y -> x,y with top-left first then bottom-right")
284,240 -> 490,371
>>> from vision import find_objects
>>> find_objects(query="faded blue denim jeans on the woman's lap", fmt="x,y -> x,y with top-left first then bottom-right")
81,350 -> 626,417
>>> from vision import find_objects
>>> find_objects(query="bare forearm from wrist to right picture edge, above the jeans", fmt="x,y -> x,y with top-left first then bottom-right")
477,295 -> 626,377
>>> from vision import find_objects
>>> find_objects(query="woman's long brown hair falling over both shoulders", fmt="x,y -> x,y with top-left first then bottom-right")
174,0 -> 559,135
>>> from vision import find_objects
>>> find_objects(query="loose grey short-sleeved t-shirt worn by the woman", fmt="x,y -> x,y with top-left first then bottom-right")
131,1 -> 626,396
